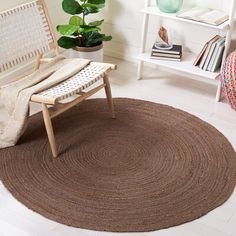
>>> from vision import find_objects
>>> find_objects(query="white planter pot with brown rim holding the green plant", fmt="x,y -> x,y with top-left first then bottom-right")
68,44 -> 103,62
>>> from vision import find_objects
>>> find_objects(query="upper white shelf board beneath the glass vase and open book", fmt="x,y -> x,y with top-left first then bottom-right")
141,6 -> 229,30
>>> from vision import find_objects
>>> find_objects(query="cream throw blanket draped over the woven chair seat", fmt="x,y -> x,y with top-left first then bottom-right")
0,55 -> 90,148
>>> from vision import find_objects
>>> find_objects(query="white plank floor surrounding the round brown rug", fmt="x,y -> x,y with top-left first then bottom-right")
0,58 -> 236,236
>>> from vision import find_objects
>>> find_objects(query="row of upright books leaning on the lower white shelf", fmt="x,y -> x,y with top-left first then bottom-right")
194,35 -> 225,72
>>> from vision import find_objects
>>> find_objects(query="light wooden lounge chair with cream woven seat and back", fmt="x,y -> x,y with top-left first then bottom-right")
0,0 -> 116,157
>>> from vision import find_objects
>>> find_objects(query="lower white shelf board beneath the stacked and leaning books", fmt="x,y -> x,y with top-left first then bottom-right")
137,52 -> 220,80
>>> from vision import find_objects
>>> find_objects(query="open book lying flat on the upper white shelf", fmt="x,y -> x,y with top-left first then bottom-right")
177,7 -> 229,26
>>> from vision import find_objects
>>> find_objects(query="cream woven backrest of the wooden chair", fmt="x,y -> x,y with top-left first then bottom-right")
0,0 -> 58,72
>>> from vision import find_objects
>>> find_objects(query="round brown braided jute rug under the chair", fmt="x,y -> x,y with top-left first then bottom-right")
0,99 -> 236,232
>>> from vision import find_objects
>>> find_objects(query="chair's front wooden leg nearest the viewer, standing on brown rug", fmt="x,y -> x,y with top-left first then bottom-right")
42,103 -> 57,158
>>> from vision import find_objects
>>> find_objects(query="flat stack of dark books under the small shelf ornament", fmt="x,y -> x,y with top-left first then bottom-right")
151,44 -> 182,61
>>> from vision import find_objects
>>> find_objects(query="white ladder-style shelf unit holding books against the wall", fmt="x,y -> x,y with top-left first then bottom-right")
137,0 -> 236,101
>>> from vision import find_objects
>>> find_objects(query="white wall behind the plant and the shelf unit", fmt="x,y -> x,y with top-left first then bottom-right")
0,0 -> 232,60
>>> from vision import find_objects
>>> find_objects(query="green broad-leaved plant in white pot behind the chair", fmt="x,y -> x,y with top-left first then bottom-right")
57,0 -> 112,61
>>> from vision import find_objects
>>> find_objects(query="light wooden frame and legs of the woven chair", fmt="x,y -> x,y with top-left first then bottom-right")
0,0 -> 116,158
